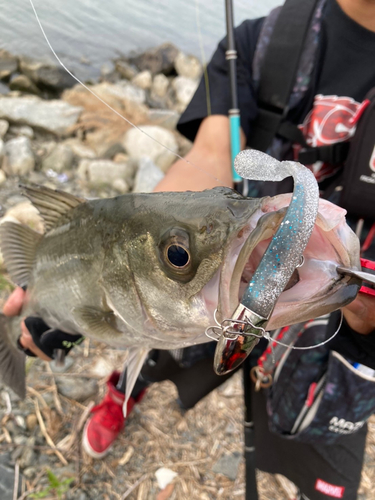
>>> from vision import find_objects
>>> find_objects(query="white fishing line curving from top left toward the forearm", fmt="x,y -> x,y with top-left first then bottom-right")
29,0 -> 224,184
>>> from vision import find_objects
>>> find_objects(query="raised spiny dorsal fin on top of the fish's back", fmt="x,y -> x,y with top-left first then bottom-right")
21,184 -> 86,231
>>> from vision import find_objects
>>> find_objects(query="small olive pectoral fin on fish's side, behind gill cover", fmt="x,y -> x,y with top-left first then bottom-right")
73,307 -> 123,341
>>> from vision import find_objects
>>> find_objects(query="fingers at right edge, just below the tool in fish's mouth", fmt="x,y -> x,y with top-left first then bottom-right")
343,293 -> 375,335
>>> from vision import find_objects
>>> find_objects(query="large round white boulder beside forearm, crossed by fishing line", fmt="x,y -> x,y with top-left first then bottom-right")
124,125 -> 178,172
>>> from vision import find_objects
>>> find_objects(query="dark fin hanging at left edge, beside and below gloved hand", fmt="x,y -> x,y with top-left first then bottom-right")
0,314 -> 26,399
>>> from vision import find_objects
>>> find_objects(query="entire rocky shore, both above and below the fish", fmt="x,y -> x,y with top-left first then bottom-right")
0,43 -> 375,500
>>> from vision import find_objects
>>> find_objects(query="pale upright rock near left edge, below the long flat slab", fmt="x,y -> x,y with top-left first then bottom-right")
3,136 -> 35,176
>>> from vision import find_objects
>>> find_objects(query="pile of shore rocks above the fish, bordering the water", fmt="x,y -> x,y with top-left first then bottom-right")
0,43 -> 202,221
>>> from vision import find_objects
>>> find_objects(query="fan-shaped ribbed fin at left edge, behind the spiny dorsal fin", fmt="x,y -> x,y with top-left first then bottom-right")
0,221 -> 43,286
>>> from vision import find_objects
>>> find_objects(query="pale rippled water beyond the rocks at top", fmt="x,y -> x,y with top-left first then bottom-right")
0,0 -> 281,78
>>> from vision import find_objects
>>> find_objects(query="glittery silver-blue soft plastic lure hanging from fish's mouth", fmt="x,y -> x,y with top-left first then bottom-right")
214,150 -> 319,374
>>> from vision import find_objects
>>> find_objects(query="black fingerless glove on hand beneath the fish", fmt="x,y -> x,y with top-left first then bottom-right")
17,316 -> 85,358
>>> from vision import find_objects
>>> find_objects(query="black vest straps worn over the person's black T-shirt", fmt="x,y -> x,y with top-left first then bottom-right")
249,0 -> 375,220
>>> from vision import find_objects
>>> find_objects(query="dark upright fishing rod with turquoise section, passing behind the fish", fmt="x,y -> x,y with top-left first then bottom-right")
225,0 -> 258,500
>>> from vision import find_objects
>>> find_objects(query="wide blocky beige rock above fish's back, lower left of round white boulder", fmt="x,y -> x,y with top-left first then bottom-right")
77,160 -> 134,187
